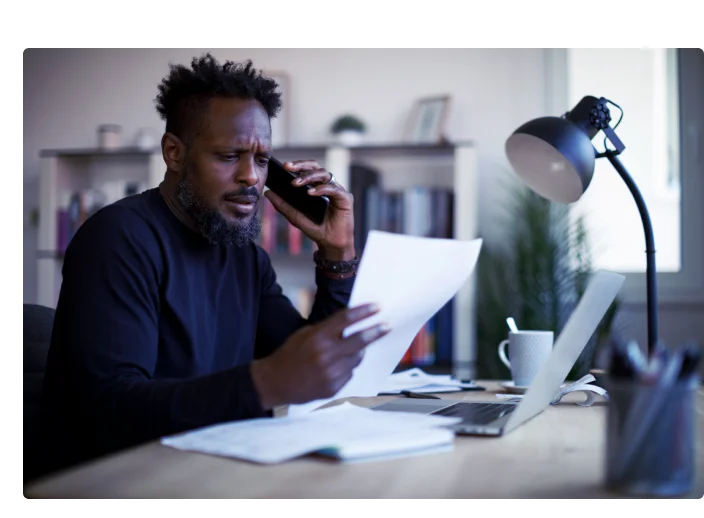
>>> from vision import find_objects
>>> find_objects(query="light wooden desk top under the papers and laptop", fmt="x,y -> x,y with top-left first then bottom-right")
19,382 -> 704,503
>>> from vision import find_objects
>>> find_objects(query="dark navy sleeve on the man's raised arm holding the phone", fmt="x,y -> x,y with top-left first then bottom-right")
255,249 -> 355,358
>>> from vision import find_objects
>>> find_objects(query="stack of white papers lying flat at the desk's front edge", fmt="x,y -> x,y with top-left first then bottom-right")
161,402 -> 460,464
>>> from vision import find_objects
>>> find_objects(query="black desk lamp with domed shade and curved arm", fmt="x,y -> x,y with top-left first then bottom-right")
506,96 -> 657,356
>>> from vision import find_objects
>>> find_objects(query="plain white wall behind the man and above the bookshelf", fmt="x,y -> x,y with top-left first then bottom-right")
16,48 -> 704,372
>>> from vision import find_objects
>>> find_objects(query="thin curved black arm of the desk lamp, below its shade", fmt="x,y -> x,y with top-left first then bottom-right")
604,151 -> 658,356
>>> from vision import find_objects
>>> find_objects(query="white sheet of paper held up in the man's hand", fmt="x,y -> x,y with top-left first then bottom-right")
288,230 -> 482,415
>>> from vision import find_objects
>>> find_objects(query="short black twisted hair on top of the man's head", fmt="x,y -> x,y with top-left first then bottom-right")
155,53 -> 282,145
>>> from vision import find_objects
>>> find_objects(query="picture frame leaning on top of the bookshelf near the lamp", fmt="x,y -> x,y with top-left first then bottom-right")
403,95 -> 450,144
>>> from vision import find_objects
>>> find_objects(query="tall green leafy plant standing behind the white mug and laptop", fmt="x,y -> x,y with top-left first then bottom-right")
477,179 -> 620,380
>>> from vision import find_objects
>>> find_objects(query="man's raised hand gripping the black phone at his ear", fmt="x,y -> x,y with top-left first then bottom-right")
265,157 -> 355,261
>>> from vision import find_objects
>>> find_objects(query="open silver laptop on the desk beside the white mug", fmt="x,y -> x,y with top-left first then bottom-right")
372,270 -> 625,437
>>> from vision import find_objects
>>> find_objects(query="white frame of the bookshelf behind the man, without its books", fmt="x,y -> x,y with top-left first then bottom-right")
37,142 -> 478,378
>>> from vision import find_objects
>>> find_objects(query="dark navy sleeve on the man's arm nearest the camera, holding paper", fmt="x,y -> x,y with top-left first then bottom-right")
45,207 -> 265,468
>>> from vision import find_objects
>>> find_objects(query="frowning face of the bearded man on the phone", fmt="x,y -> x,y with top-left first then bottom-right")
177,97 -> 271,246
